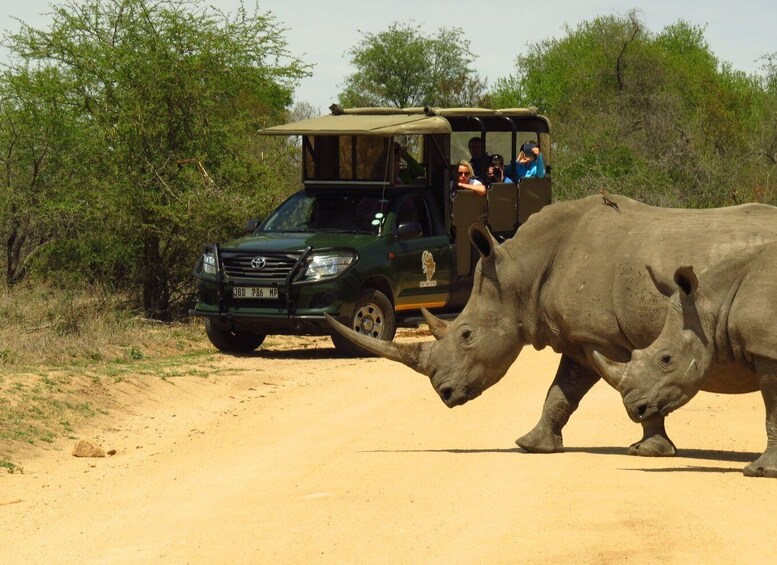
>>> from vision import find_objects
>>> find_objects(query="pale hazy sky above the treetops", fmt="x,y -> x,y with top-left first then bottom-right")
0,0 -> 777,113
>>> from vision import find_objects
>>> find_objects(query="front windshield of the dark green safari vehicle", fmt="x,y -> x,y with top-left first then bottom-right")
262,192 -> 391,234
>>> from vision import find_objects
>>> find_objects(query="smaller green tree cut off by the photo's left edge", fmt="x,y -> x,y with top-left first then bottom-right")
0,69 -> 94,284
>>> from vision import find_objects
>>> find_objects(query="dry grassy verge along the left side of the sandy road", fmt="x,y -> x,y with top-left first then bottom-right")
0,286 -> 214,472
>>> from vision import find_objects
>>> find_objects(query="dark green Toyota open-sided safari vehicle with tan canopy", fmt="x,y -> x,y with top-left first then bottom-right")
191,106 -> 552,355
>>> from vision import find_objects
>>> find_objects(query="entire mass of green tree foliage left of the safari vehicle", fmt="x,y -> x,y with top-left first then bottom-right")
0,0 -> 308,318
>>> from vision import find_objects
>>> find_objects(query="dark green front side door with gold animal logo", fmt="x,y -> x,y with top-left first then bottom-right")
392,194 -> 451,311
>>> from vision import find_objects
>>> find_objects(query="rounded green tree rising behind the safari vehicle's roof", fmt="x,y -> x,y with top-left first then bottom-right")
340,22 -> 485,108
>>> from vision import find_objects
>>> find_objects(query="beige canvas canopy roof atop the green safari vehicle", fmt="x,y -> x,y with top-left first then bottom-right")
260,106 -> 550,136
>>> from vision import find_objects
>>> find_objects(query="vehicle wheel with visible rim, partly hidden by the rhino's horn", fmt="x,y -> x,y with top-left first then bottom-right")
332,288 -> 397,357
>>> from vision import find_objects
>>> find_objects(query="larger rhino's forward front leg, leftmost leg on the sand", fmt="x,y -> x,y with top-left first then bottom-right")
515,355 -> 599,453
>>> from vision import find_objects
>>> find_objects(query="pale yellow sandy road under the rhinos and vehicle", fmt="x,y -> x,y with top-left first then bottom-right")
0,330 -> 777,564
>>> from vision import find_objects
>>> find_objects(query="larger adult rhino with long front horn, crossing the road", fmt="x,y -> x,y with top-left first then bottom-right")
330,195 -> 777,456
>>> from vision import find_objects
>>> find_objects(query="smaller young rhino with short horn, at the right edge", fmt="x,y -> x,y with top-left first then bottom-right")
593,243 -> 777,477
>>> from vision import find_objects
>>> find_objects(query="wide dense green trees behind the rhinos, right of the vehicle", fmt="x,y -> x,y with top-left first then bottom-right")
491,12 -> 768,206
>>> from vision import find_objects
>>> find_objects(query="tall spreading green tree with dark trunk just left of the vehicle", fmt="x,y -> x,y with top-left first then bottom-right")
8,0 -> 309,319
